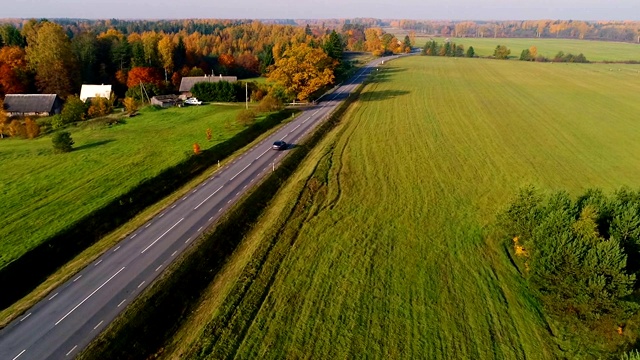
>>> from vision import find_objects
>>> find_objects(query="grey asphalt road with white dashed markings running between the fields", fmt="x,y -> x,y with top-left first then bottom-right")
0,57 -> 394,360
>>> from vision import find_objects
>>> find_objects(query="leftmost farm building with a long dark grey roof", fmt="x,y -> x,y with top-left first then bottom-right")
4,94 -> 62,117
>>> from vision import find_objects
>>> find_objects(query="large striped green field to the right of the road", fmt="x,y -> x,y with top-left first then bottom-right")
164,57 -> 640,359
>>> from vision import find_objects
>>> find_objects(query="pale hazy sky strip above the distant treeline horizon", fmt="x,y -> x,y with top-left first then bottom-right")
5,0 -> 640,20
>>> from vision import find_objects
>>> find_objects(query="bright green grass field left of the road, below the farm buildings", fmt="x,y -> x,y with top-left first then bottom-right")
0,105 -> 248,268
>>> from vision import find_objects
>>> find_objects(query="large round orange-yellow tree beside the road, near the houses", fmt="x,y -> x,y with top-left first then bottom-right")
269,43 -> 337,101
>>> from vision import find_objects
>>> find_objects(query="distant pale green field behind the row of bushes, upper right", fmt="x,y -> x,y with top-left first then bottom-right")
416,37 -> 640,62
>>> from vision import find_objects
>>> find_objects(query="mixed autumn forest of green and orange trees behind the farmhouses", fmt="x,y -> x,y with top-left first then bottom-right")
0,19 -> 410,102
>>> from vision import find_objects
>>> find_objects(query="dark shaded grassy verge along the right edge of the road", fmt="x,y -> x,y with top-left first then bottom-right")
79,77 -> 360,359
